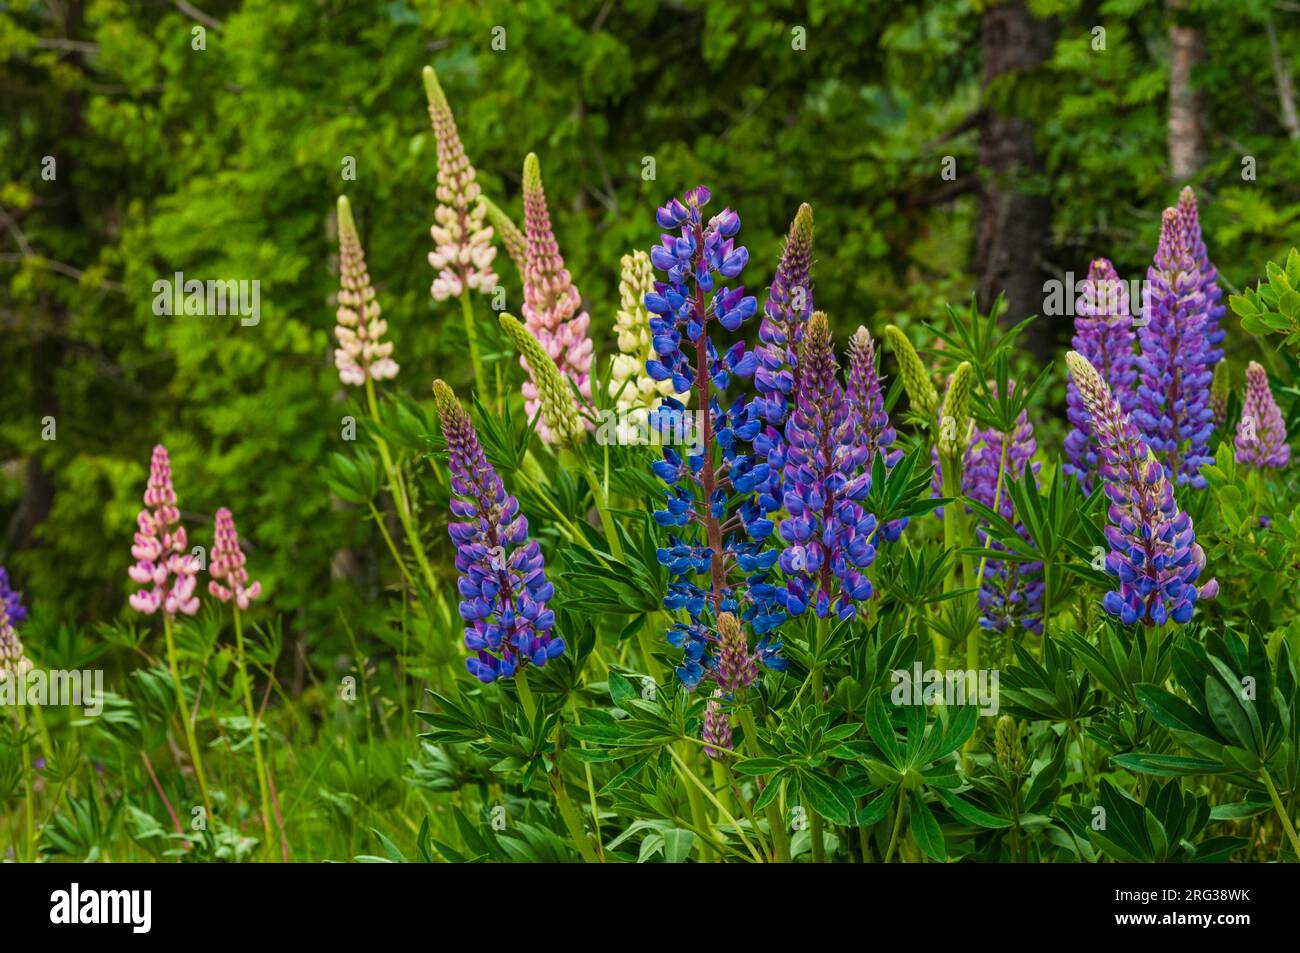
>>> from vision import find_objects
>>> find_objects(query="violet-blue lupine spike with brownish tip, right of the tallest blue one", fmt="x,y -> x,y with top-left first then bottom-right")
770,311 -> 876,619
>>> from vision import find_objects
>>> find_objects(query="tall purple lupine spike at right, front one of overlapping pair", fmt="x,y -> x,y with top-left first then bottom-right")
1131,208 -> 1214,488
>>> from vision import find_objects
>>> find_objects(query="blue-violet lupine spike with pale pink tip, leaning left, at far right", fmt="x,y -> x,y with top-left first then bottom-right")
1066,351 -> 1218,627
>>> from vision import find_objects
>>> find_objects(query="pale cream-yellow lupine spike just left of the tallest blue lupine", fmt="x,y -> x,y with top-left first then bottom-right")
610,248 -> 690,434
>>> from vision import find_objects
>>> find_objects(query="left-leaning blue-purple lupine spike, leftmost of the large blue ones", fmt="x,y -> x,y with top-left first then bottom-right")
433,381 -> 564,683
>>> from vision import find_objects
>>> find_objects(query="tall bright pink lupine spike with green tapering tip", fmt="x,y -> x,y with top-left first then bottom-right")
520,152 -> 592,441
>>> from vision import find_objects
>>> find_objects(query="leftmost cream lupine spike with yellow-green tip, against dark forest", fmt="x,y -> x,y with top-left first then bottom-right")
334,195 -> 398,387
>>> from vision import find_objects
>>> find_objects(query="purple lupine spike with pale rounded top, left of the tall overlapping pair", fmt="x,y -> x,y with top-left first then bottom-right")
1062,259 -> 1138,493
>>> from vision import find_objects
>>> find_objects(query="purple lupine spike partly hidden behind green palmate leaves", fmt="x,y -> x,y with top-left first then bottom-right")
962,381 -> 1043,632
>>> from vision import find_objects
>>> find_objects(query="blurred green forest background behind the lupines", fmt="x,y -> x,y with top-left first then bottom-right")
0,0 -> 1300,670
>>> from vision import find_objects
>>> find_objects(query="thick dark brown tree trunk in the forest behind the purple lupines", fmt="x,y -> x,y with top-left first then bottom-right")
975,0 -> 1056,359
